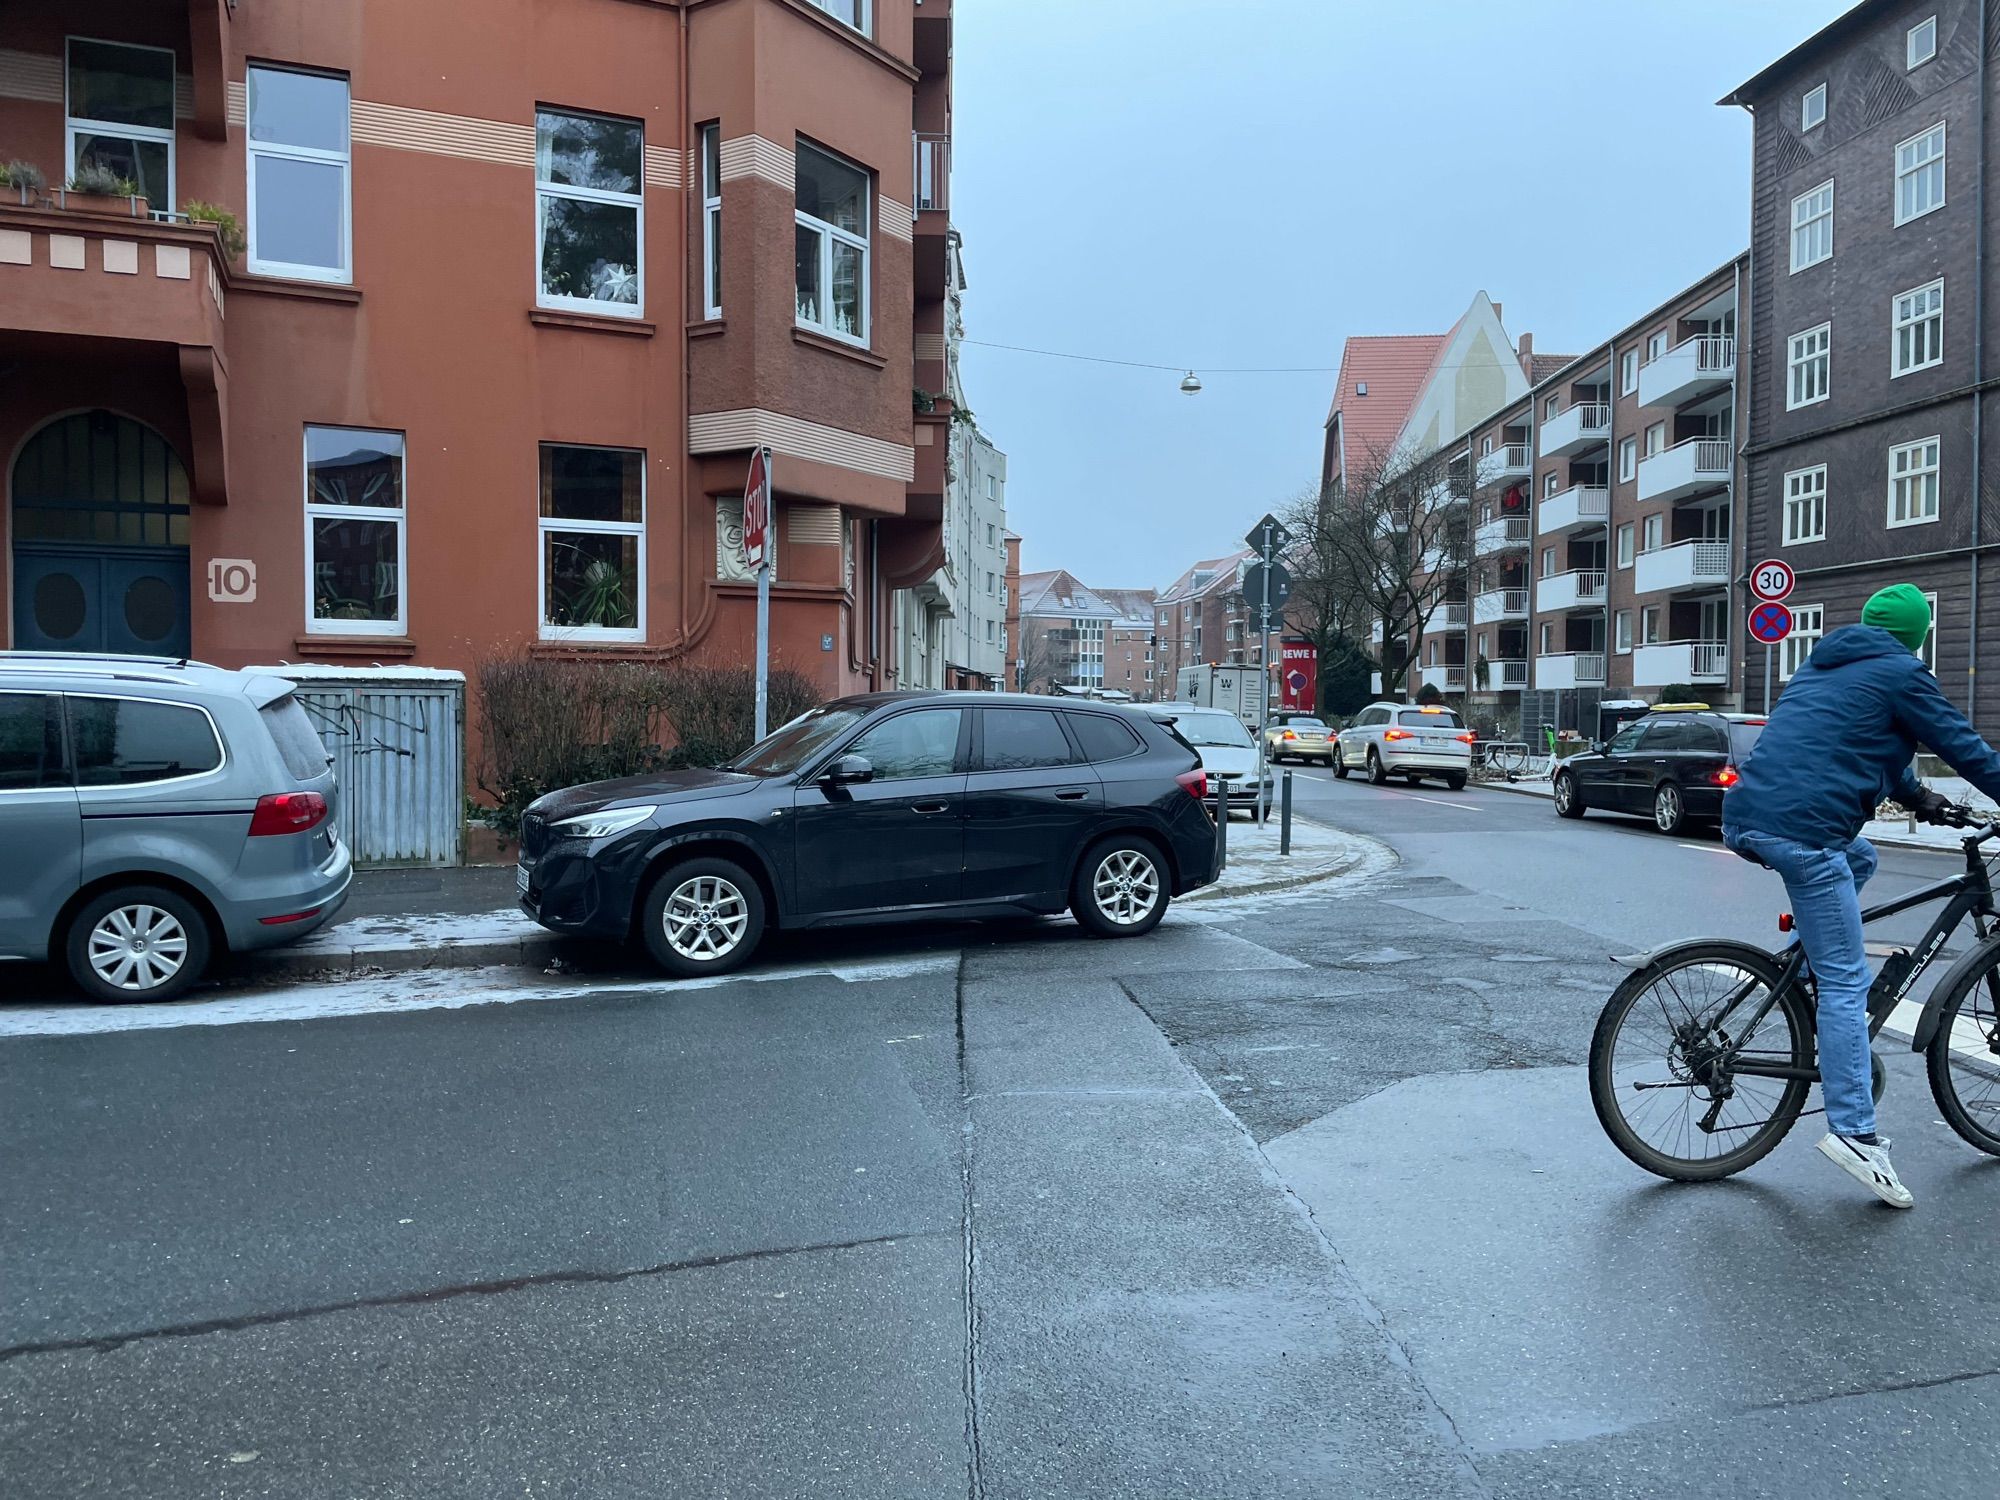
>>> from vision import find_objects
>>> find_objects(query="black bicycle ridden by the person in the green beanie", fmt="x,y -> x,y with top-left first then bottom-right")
1590,806 -> 2000,1182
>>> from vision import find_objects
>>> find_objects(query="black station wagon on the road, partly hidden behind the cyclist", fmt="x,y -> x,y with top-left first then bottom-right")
1556,704 -> 1764,834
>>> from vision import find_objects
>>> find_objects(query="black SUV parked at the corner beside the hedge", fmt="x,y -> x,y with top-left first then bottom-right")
518,692 -> 1216,974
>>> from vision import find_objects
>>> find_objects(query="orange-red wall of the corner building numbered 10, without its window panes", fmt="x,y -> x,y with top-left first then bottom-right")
0,0 -> 952,692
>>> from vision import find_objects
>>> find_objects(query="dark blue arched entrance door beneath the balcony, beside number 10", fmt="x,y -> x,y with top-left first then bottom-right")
12,412 -> 188,656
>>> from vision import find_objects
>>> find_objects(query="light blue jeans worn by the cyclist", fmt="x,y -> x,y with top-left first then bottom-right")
1722,828 -> 1876,1136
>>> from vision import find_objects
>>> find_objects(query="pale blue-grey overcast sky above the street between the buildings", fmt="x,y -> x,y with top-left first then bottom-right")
952,0 -> 1850,588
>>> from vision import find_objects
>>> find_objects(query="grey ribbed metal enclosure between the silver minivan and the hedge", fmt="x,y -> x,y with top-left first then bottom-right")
268,666 -> 466,866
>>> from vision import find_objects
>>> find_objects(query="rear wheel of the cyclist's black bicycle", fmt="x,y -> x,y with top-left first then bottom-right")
1590,942 -> 1814,1182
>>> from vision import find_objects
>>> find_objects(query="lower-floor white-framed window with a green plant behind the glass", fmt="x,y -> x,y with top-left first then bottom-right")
540,442 -> 646,640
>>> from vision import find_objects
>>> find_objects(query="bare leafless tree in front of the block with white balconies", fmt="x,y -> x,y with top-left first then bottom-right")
1286,444 -> 1472,704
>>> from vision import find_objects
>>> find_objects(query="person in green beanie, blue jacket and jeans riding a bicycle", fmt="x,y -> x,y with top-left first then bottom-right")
1722,584 -> 2000,1208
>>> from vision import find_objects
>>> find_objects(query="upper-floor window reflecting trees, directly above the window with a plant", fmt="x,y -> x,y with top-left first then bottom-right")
534,110 -> 646,318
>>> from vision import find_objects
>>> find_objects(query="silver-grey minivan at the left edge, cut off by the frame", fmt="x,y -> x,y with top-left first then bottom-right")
0,652 -> 354,1000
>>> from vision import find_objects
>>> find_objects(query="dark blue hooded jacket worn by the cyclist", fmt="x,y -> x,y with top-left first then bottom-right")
1722,626 -> 2000,848
